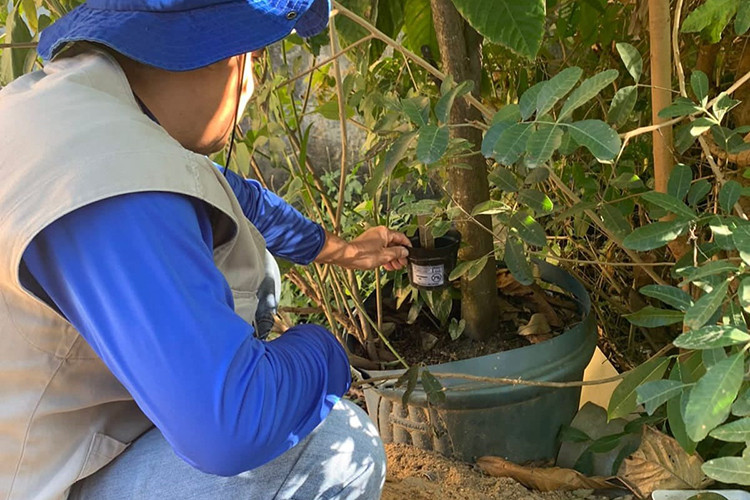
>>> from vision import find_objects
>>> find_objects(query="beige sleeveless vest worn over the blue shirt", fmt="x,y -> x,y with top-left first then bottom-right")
0,51 -> 265,500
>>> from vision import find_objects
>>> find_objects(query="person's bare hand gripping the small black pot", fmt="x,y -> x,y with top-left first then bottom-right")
315,226 -> 411,271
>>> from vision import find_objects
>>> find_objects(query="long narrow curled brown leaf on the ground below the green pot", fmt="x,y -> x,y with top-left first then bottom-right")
477,457 -> 617,491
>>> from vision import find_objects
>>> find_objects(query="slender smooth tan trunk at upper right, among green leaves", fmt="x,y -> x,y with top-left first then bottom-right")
644,0 -> 674,193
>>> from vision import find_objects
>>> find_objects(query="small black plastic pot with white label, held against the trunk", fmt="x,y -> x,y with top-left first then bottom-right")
408,230 -> 461,290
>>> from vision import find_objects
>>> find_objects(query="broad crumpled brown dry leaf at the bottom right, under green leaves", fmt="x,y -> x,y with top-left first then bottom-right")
617,426 -> 706,498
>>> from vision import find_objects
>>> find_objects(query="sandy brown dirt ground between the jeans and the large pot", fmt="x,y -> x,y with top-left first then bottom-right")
382,443 -> 628,500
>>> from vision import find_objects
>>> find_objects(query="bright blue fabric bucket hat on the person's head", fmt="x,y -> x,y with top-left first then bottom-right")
37,0 -> 331,71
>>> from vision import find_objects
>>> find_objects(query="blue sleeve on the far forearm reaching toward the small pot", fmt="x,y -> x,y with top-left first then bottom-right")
221,167 -> 326,264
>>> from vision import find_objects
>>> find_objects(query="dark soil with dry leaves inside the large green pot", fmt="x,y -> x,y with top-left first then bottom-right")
389,270 -> 581,365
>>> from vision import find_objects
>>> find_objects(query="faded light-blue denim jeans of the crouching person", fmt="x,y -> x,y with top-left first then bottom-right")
69,400 -> 385,500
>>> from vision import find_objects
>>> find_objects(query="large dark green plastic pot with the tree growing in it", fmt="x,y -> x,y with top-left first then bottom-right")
365,262 -> 597,463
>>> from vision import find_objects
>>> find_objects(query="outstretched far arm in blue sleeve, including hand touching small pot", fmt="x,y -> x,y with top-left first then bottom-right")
227,170 -> 411,271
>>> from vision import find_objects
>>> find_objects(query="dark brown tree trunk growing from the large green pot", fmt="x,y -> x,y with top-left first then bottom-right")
431,0 -> 499,339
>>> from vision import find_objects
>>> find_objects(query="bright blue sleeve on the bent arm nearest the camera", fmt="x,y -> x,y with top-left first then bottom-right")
24,192 -> 350,475
